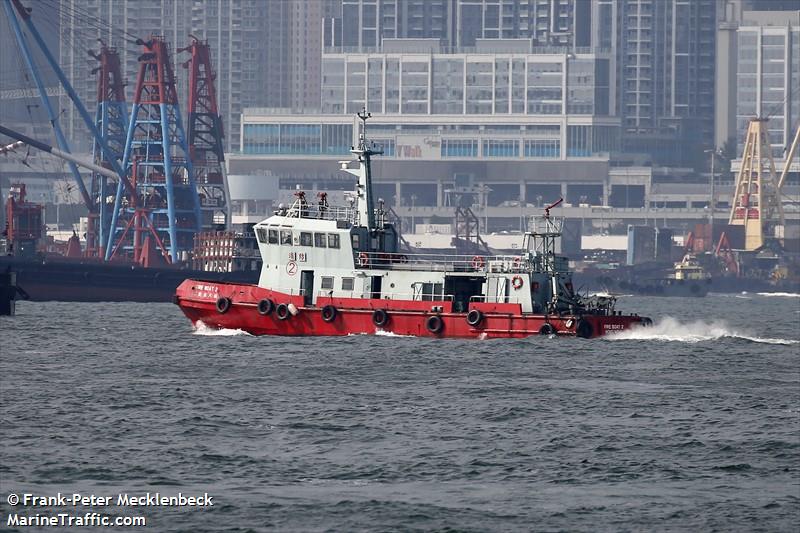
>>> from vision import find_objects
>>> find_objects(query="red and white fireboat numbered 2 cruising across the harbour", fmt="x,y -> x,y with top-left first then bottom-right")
175,110 -> 652,339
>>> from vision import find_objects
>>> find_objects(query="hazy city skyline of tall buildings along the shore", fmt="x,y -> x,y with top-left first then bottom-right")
2,0 -> 800,229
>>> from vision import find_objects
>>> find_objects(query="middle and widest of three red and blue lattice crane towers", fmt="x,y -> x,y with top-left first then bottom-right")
105,35 -> 201,263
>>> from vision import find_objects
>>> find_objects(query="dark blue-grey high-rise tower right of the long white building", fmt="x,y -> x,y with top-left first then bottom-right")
612,0 -> 717,165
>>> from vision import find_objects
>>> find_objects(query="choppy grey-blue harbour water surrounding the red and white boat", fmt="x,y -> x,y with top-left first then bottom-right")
0,294 -> 800,531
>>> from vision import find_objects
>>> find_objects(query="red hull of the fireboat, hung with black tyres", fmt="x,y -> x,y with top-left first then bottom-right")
175,280 -> 648,339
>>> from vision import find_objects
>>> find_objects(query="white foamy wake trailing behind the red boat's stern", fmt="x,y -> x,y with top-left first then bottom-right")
604,317 -> 800,344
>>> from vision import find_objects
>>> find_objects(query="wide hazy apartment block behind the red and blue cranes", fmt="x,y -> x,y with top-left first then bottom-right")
54,0 -> 332,154
